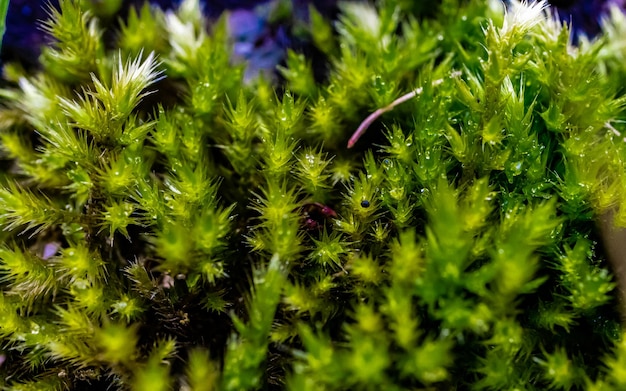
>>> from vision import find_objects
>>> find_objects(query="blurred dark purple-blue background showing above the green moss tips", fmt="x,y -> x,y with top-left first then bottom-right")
2,0 -> 626,72
